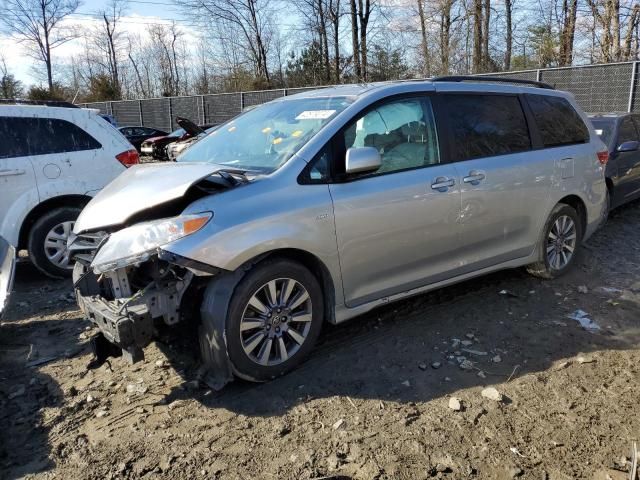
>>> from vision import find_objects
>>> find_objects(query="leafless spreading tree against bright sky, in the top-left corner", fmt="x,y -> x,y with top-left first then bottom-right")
0,0 -> 80,93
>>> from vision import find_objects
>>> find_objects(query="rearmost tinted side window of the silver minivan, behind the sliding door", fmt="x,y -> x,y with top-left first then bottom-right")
526,94 -> 589,147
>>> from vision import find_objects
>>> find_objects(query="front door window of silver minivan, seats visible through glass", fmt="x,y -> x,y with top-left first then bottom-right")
339,99 -> 440,174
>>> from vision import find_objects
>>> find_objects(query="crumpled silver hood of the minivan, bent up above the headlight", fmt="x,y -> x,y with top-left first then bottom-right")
73,163 -> 220,234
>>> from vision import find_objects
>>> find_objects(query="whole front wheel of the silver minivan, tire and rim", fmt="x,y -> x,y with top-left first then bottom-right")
225,259 -> 324,382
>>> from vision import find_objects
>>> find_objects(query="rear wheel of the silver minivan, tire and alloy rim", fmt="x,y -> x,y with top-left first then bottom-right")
527,203 -> 582,280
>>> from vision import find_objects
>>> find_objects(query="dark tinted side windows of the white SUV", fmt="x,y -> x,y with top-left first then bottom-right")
0,117 -> 102,158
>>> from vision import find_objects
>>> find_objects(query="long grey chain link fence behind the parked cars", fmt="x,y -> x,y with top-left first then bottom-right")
81,62 -> 640,131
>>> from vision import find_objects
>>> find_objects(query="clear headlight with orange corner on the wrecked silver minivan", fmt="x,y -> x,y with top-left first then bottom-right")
91,212 -> 213,274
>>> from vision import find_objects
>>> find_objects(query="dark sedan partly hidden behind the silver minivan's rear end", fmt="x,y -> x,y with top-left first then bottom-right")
589,113 -> 640,214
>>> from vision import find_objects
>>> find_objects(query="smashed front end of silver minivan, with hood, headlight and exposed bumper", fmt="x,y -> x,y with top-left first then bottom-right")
68,164 -> 256,388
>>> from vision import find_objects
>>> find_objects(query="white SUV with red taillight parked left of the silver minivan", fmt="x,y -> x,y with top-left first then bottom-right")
0,101 -> 138,277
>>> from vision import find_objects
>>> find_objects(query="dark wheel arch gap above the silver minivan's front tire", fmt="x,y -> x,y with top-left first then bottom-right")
245,248 -> 336,323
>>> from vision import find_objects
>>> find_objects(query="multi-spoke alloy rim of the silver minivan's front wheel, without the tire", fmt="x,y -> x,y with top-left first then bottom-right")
240,278 -> 313,366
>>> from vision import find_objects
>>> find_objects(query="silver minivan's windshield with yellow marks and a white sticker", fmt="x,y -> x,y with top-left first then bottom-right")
177,97 -> 351,173
